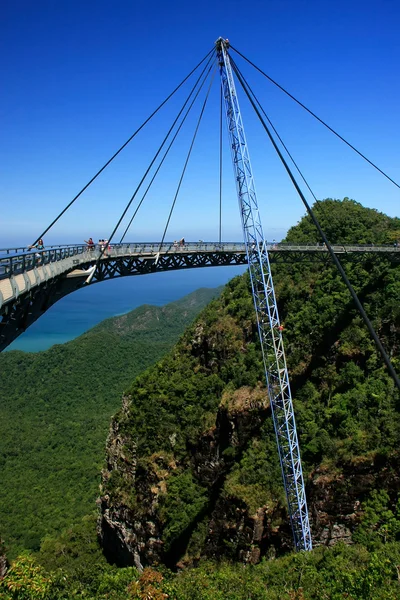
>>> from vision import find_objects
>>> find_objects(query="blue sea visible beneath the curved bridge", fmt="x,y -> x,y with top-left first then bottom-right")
7,266 -> 246,352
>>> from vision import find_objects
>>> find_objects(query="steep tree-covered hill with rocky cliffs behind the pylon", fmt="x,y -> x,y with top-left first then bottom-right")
100,200 -> 400,567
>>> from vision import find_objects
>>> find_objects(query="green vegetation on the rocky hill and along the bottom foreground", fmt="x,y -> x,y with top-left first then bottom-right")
0,199 -> 400,600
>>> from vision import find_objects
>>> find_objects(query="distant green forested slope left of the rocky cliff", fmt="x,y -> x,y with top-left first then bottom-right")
0,289 -> 218,557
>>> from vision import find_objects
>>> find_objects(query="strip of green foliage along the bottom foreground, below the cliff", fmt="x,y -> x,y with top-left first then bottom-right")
0,517 -> 400,600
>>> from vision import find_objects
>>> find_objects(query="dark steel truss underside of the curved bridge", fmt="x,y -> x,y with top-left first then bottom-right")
0,249 -> 400,352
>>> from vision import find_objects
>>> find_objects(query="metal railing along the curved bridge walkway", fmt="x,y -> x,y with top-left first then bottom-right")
0,241 -> 400,279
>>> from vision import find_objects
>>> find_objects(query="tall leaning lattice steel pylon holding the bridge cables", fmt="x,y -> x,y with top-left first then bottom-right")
216,38 -> 312,550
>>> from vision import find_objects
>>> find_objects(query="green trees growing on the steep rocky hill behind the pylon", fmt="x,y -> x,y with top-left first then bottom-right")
100,199 -> 400,562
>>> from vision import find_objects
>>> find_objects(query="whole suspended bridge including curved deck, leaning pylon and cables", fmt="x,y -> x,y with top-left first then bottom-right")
0,37 -> 400,550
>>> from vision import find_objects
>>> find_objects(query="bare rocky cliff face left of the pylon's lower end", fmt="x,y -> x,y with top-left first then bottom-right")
98,387 -> 291,568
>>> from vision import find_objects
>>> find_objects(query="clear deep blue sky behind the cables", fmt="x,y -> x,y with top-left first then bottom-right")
0,0 -> 400,247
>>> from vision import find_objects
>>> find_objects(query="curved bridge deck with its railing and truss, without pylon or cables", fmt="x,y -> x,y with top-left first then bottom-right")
0,242 -> 400,351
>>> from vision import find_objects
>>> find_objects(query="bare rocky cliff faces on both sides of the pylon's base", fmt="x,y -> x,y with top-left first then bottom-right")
99,388 -> 400,569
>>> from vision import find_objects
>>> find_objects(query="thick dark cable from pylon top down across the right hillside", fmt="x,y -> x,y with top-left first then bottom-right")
232,59 -> 400,390
